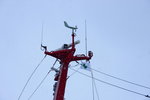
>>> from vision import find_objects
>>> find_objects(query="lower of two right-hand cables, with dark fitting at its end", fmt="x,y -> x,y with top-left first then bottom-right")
70,68 -> 150,98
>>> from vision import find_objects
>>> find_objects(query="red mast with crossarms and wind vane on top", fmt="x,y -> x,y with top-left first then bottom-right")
41,22 -> 93,100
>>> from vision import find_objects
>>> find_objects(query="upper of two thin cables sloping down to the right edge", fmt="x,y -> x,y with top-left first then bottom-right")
91,68 -> 150,89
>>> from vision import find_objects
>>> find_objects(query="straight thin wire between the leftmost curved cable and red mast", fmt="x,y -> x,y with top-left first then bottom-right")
28,59 -> 58,100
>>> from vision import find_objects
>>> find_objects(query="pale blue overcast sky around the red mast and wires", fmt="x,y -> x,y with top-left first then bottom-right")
0,0 -> 150,100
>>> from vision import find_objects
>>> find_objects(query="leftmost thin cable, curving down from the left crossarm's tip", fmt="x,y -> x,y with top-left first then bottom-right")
18,55 -> 46,100
